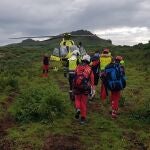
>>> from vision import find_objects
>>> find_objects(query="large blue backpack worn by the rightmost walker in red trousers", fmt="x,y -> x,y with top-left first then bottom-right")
105,63 -> 126,91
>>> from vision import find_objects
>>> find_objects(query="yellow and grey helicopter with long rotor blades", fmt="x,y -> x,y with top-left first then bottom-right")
10,33 -> 95,69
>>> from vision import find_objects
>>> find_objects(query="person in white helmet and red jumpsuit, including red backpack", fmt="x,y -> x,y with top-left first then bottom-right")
73,55 -> 94,124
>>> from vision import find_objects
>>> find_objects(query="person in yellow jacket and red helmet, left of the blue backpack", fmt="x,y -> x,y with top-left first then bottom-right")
100,48 -> 112,102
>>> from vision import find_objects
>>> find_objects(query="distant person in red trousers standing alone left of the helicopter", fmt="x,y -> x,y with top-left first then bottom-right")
42,53 -> 49,77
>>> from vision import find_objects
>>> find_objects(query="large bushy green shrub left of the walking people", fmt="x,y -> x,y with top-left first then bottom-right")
10,86 -> 65,122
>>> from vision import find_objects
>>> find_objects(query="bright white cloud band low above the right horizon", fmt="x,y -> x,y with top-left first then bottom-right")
94,27 -> 150,45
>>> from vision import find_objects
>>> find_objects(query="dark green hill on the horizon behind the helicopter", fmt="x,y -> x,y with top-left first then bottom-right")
6,30 -> 112,50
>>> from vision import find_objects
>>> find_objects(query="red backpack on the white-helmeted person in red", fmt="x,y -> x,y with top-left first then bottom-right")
73,65 -> 92,92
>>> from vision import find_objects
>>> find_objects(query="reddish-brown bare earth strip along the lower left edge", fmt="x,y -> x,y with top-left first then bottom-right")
0,92 -> 18,150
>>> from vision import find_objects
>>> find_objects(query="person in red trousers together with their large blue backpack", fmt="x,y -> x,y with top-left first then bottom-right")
105,56 -> 126,119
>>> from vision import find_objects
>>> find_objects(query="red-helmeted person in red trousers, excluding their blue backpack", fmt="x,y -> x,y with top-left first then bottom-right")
107,56 -> 126,119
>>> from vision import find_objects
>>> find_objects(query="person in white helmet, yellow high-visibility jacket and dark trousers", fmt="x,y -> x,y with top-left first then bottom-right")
67,50 -> 80,100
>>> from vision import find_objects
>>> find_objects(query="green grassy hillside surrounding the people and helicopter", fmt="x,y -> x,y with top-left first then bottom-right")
0,31 -> 150,150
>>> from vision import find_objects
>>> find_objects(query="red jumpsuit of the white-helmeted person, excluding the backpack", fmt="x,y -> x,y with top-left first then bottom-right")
75,64 -> 94,119
